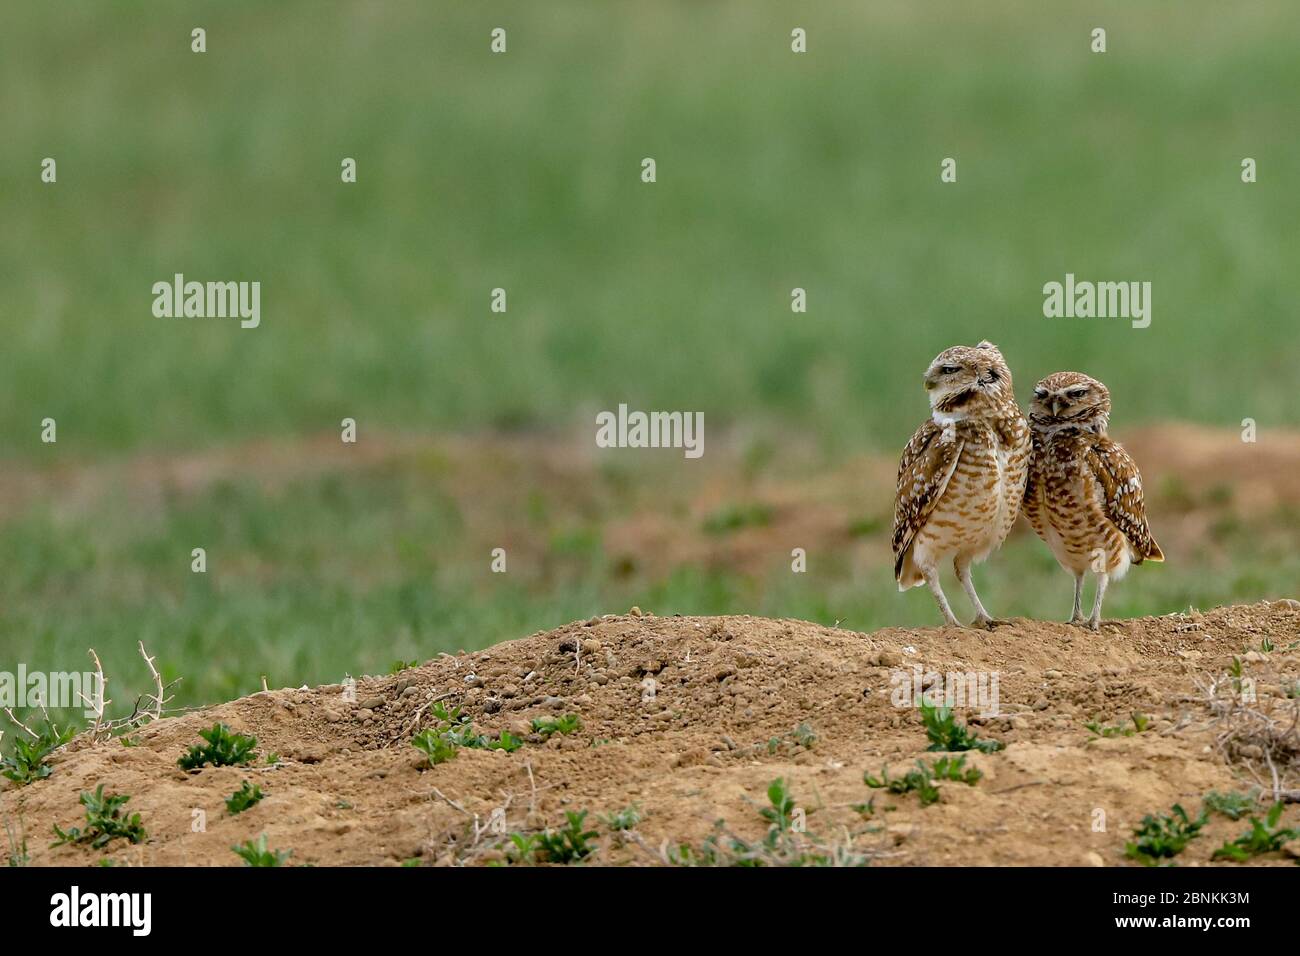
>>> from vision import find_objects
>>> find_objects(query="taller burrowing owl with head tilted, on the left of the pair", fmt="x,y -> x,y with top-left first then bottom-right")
893,342 -> 1030,627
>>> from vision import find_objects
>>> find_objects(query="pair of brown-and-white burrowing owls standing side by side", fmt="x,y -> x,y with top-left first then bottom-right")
893,342 -> 1165,631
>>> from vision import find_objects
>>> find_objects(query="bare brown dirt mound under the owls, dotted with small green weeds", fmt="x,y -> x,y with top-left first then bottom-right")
0,601 -> 1300,865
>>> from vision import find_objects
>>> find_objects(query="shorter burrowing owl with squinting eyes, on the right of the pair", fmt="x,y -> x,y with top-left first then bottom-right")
1024,372 -> 1165,631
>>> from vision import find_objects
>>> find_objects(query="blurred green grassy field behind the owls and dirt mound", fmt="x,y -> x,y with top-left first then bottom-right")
0,0 -> 1300,723
